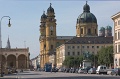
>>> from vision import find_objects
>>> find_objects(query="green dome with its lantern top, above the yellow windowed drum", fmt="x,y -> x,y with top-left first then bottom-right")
77,3 -> 97,23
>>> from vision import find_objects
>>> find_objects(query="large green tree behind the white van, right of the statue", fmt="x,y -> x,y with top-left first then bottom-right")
98,46 -> 113,66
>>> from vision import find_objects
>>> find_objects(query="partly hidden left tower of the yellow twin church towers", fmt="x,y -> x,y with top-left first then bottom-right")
39,11 -> 47,67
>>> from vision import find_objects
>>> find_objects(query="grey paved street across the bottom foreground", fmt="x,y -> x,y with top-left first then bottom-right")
0,71 -> 120,79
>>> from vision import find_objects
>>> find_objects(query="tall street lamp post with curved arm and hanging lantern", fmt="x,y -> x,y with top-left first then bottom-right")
0,16 -> 11,77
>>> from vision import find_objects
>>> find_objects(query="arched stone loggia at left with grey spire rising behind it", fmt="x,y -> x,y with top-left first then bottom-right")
0,38 -> 30,74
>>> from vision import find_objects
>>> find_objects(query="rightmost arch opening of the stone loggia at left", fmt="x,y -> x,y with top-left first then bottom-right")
18,54 -> 27,69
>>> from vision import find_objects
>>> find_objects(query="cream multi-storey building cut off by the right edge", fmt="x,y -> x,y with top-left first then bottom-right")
111,12 -> 120,68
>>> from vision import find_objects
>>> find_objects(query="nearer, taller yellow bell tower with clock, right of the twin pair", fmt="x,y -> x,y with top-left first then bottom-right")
45,3 -> 56,64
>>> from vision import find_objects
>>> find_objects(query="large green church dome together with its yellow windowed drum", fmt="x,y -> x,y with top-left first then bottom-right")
76,2 -> 98,37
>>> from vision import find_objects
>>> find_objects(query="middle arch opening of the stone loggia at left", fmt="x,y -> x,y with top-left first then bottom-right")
7,54 -> 16,68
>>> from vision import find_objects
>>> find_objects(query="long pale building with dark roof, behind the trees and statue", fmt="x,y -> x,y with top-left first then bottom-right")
56,36 -> 113,68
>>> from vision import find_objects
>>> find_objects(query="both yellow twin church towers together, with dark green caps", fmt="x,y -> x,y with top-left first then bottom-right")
39,3 -> 56,68
